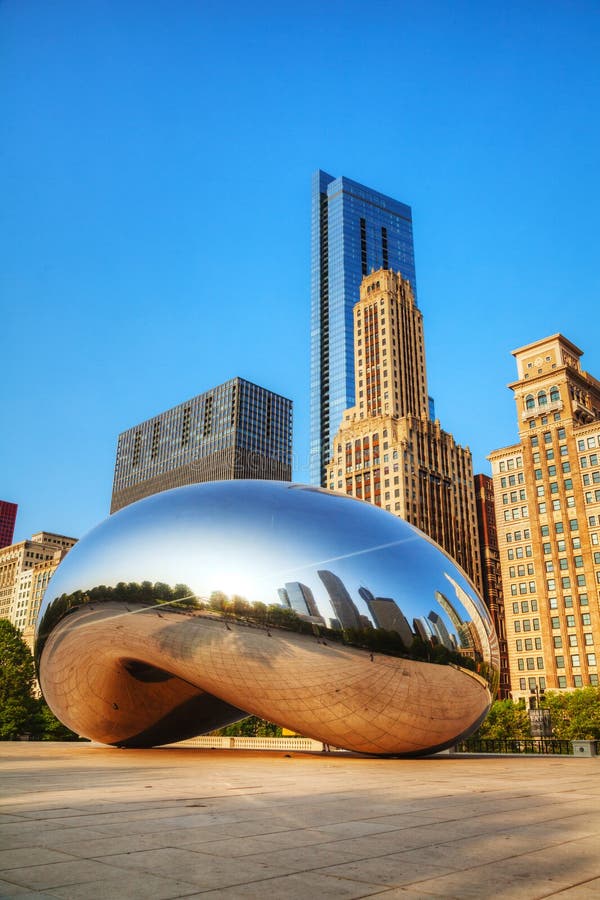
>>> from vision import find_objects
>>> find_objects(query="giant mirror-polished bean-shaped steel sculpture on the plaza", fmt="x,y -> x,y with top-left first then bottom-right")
36,481 -> 498,754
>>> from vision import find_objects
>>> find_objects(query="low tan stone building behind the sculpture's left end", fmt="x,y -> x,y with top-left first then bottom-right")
0,531 -> 77,647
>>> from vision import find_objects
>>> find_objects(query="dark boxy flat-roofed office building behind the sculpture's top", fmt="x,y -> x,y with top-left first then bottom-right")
110,378 -> 292,513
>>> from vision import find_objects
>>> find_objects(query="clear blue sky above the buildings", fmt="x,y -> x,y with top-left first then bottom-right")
0,0 -> 600,539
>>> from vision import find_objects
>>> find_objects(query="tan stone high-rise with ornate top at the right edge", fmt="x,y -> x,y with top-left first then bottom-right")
489,334 -> 600,699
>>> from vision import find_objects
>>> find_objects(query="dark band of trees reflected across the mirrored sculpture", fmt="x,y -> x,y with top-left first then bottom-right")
36,581 -> 478,674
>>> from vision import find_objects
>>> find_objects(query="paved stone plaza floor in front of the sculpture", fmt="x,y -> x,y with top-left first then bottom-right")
0,743 -> 600,900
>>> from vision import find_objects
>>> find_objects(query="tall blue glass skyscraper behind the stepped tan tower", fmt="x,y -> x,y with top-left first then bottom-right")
310,169 -> 416,485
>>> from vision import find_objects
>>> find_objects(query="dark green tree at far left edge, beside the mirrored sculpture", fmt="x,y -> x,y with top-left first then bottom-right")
0,619 -> 36,741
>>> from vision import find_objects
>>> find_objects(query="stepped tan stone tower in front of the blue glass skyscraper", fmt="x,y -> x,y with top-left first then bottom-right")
327,269 -> 481,588
